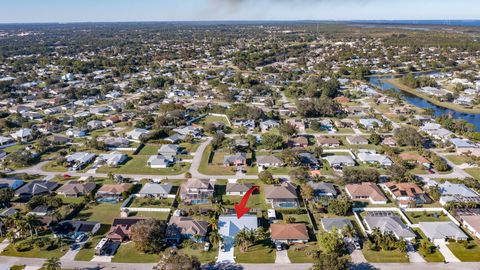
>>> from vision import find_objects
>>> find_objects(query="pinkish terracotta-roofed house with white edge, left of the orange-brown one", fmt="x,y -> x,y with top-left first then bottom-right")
345,182 -> 388,204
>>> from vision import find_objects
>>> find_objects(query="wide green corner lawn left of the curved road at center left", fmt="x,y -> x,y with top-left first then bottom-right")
97,155 -> 190,175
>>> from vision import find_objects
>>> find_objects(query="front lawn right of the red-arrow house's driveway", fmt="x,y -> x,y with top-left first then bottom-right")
234,240 -> 277,263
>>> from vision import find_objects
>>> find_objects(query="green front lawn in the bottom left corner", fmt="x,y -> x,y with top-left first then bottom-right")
1,234 -> 69,258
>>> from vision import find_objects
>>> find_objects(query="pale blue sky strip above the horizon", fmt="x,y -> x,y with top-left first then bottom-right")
0,0 -> 480,23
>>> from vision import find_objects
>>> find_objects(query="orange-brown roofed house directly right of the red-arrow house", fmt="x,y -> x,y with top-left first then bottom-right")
270,223 -> 309,244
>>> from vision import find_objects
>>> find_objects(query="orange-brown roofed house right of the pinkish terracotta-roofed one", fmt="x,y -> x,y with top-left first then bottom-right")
382,182 -> 432,208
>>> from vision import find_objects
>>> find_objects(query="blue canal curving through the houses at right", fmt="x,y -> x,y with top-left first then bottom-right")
369,76 -> 480,131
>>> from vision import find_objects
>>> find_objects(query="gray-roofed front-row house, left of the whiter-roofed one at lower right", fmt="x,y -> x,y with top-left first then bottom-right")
364,215 -> 416,241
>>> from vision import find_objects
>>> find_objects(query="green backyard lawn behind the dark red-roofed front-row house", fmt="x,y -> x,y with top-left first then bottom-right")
75,203 -> 121,225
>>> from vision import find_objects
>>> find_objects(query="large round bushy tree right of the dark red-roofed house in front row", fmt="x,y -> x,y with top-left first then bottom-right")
132,219 -> 166,253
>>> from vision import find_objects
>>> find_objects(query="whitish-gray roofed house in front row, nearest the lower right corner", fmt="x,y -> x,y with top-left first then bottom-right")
418,221 -> 468,244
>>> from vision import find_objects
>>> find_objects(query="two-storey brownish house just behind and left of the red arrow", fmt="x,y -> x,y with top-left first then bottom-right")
180,178 -> 214,204
